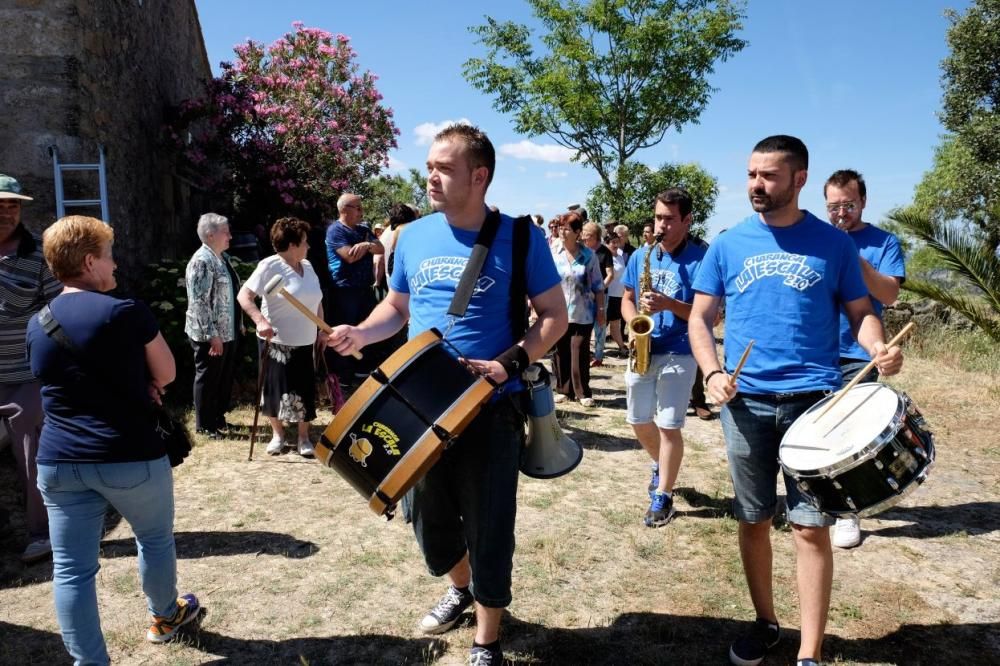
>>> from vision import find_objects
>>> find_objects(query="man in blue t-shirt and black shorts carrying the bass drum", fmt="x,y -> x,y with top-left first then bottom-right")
331,125 -> 567,665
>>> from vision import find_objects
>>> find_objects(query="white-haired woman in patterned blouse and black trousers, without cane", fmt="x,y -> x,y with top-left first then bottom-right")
184,213 -> 242,439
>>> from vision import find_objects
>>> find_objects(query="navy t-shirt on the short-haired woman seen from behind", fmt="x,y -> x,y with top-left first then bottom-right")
27,291 -> 165,463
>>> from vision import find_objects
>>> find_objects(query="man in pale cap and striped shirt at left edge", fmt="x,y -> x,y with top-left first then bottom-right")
0,174 -> 62,563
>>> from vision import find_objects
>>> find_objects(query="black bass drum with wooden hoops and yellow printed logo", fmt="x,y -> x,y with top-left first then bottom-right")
316,329 -> 493,517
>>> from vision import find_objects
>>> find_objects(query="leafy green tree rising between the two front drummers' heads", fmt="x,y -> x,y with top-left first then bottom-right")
464,0 -> 746,219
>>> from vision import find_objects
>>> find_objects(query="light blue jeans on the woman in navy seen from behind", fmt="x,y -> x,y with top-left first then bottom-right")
38,456 -> 177,666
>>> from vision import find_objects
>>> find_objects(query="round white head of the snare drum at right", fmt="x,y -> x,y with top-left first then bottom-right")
778,383 -> 903,472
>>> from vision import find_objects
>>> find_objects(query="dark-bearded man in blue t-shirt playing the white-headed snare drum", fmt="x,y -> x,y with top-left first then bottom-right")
689,136 -> 903,666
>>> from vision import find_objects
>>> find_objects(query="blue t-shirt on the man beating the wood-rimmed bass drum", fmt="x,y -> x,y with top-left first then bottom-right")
389,213 -> 559,389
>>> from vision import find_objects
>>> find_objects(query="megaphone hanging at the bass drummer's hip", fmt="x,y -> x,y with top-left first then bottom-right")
521,363 -> 583,479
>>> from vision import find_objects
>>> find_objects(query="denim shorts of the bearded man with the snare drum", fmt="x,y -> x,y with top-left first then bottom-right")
721,391 -> 836,527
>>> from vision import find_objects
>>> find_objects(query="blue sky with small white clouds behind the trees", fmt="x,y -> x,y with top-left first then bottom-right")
196,0 -> 968,237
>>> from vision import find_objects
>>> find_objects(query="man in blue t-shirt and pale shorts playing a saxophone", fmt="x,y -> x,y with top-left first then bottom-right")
622,187 -> 705,527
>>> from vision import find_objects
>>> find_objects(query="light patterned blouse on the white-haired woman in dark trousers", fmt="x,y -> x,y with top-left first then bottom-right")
184,245 -> 240,342
